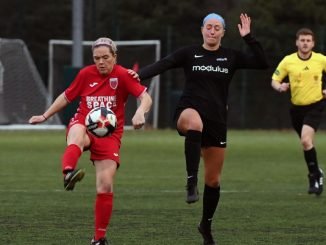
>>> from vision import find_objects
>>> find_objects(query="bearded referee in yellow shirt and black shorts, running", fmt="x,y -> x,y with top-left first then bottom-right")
271,28 -> 326,196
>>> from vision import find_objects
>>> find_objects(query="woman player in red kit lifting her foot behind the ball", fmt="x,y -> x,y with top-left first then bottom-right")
29,38 -> 152,245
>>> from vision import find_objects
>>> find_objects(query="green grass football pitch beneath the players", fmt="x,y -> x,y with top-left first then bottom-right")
0,130 -> 326,245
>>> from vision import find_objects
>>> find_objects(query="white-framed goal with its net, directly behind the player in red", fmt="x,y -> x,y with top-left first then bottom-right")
47,39 -> 161,128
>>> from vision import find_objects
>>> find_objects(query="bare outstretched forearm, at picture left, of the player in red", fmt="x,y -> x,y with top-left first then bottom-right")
28,92 -> 69,124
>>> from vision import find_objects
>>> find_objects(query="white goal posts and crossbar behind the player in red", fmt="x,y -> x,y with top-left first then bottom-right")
47,39 -> 161,129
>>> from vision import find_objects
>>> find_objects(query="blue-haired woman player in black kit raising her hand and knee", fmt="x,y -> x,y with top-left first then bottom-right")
132,13 -> 268,244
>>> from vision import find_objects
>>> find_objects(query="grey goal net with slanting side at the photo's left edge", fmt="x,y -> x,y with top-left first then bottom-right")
0,38 -> 62,128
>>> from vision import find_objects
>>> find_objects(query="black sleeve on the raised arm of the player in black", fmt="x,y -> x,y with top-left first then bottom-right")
237,33 -> 268,69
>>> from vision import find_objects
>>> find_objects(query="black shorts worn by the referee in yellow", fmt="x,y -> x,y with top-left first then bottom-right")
290,100 -> 326,137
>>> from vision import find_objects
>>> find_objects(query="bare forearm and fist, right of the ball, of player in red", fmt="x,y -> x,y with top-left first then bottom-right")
131,91 -> 152,129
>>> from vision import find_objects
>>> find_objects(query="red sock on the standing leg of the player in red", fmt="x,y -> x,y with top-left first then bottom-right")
94,192 -> 113,241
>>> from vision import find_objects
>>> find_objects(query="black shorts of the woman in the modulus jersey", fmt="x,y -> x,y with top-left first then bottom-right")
174,109 -> 227,148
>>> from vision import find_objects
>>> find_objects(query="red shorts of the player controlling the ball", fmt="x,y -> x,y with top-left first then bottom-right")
67,114 -> 121,164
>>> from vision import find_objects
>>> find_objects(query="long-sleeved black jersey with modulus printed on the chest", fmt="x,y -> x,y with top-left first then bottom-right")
139,35 -> 267,124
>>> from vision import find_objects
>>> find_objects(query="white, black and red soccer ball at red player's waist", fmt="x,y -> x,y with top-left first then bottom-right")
85,107 -> 117,137
